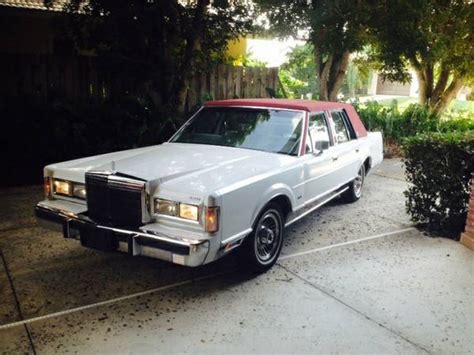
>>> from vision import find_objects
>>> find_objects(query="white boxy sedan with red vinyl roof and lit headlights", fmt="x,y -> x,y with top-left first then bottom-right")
35,99 -> 383,272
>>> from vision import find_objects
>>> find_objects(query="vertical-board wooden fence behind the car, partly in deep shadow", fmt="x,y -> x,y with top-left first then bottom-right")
0,53 -> 279,108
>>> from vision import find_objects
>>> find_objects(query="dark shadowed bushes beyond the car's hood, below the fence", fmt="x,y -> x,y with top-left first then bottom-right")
0,97 -> 179,185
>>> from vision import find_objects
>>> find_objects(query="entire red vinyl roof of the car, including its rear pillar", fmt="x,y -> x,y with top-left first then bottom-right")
204,99 -> 367,138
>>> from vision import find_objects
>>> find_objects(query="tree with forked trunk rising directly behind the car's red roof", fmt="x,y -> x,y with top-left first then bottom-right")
257,0 -> 371,101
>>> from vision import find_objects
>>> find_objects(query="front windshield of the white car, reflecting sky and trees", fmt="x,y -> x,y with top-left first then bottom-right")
171,107 -> 303,155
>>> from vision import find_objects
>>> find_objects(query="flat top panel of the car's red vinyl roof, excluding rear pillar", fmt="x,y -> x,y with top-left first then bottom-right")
205,99 -> 352,112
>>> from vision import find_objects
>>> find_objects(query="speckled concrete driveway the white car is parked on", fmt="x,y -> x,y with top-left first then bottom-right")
0,160 -> 474,354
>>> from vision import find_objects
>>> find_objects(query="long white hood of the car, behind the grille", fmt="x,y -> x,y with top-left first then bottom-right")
45,143 -> 295,196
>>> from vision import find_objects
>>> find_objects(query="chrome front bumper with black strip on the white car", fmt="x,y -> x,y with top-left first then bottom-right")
35,202 -> 210,266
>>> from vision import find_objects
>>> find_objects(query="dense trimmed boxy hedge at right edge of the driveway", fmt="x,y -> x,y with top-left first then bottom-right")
402,131 -> 474,233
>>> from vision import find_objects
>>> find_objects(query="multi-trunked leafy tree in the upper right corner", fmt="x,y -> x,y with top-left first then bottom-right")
370,0 -> 474,113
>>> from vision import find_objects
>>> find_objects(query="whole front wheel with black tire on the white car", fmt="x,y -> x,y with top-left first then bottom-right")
238,203 -> 285,273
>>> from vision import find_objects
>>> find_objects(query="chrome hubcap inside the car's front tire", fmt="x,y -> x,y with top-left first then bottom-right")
255,211 -> 281,264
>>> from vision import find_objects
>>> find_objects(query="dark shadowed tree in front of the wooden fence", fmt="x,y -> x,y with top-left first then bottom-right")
45,0 -> 253,113
